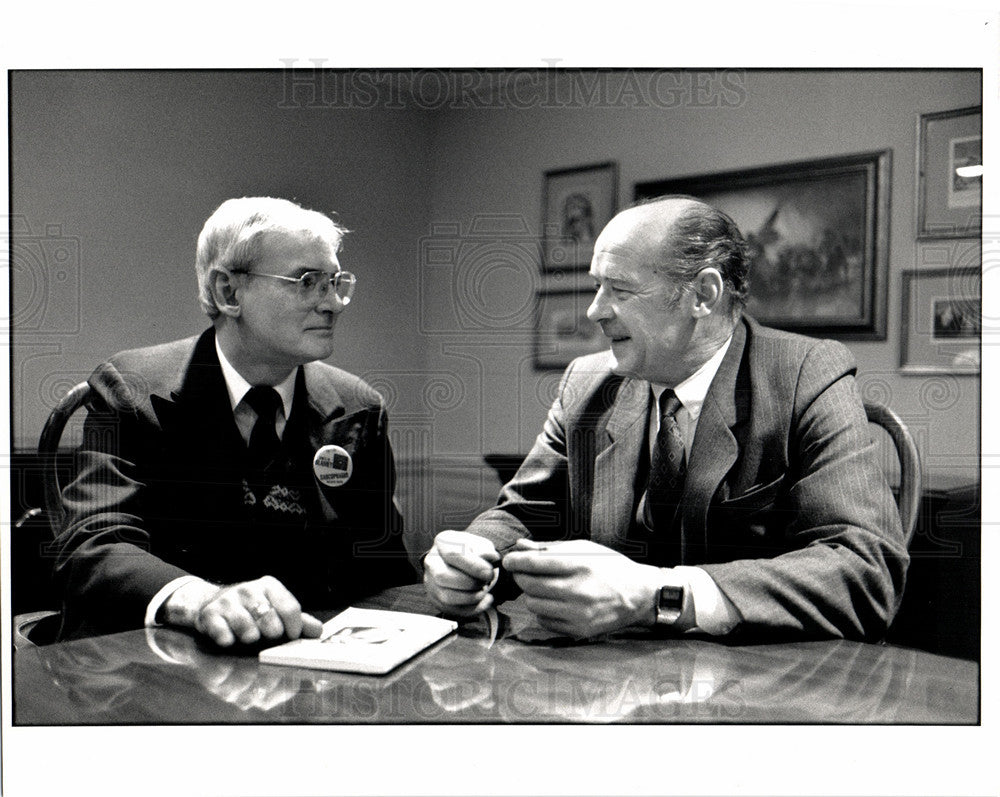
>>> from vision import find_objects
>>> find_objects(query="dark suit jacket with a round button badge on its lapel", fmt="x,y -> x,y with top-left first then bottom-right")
56,330 -> 413,637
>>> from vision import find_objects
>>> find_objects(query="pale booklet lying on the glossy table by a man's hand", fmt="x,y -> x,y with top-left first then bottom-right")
258,606 -> 458,675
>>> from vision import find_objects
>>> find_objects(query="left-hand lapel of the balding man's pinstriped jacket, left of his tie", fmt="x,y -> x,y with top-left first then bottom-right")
590,379 -> 652,548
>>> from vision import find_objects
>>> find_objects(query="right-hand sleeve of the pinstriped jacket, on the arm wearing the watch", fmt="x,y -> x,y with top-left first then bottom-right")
702,341 -> 908,638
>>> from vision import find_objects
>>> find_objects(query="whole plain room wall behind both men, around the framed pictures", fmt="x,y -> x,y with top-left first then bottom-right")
11,71 -> 980,534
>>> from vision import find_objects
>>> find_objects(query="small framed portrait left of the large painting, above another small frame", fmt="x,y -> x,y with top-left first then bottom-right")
542,161 -> 618,271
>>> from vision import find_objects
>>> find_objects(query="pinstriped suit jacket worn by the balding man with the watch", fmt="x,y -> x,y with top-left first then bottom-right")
469,318 -> 908,638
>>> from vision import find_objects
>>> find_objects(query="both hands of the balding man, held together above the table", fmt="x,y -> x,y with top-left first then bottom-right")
424,530 -> 661,639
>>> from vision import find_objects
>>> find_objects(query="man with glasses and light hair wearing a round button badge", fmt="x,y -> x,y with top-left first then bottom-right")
56,198 -> 412,646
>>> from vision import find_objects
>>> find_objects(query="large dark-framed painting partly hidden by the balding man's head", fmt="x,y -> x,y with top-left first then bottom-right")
635,150 -> 892,340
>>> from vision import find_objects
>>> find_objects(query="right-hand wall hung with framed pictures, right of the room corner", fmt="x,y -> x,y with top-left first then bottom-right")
423,70 -> 981,494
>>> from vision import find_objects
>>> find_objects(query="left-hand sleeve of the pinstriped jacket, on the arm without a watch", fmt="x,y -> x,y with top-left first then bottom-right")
458,363 -> 575,555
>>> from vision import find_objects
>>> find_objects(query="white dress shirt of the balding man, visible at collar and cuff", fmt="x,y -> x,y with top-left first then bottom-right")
648,336 -> 739,635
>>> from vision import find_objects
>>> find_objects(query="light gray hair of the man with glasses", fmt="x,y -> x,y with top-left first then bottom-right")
195,197 -> 348,320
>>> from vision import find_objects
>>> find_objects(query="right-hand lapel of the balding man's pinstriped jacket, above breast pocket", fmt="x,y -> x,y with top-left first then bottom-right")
681,321 -> 749,564
